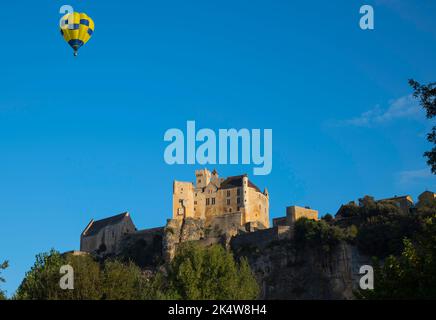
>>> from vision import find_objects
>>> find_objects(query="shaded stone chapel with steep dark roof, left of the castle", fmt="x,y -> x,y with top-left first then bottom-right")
80,212 -> 136,256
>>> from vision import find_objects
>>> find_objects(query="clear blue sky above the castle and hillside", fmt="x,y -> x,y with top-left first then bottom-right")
0,0 -> 436,294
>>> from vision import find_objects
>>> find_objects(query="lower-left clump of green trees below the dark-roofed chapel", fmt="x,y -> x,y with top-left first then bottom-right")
14,250 -> 145,300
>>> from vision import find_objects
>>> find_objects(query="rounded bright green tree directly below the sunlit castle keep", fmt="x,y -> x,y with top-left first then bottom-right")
154,243 -> 259,300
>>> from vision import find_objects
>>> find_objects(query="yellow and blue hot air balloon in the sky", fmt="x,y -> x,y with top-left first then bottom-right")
60,12 -> 94,56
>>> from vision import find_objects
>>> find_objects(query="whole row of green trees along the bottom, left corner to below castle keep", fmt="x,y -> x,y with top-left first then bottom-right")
14,244 -> 259,300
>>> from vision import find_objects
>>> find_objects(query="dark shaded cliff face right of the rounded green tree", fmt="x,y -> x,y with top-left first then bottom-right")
232,239 -> 369,300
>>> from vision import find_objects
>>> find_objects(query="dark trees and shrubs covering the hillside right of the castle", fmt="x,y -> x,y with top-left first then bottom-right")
295,196 -> 436,299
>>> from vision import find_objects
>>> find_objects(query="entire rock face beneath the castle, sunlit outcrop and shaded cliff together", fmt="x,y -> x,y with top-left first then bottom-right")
116,218 -> 371,300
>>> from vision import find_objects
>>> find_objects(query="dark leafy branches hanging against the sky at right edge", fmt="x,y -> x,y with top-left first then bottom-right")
409,79 -> 436,174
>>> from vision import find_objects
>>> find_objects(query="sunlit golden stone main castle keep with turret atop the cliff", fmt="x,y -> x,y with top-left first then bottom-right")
173,169 -> 269,229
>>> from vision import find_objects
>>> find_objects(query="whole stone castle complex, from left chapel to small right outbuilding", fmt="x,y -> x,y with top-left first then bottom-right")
80,169 -> 318,264
